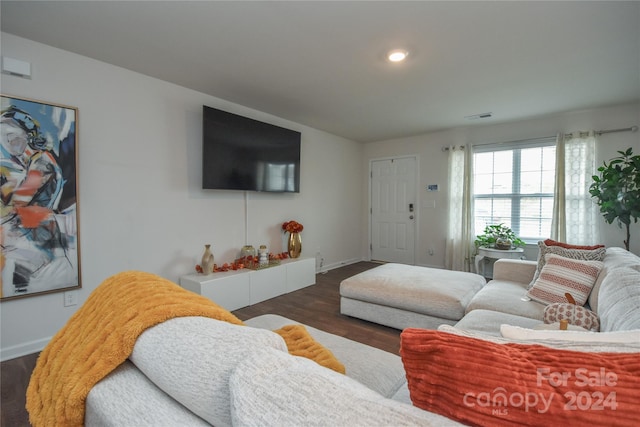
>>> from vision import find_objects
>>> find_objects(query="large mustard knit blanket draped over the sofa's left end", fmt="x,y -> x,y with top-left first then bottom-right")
26,271 -> 242,427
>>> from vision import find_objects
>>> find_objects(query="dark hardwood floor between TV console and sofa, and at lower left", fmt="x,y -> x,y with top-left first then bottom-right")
0,262 -> 400,427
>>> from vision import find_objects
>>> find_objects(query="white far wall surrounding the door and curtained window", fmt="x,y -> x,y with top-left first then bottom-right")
362,104 -> 640,268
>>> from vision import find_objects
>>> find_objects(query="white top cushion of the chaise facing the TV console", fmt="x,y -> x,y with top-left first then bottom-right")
340,263 -> 486,320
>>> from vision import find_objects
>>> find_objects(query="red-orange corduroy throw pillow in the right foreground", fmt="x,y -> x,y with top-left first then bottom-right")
400,328 -> 640,426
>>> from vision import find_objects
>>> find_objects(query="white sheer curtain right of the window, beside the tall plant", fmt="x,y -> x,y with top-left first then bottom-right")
551,131 -> 600,245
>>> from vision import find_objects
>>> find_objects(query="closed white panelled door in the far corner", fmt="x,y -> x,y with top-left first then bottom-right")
371,157 -> 417,265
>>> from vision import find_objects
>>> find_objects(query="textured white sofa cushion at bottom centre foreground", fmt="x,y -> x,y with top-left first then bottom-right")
229,348 -> 454,426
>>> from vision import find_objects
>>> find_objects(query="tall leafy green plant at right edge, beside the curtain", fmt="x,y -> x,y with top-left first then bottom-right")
589,148 -> 640,250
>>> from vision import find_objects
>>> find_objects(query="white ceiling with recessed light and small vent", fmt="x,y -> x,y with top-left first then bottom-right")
1,0 -> 640,142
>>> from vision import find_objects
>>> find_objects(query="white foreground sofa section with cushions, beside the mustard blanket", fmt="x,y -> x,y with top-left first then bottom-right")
85,315 -> 460,427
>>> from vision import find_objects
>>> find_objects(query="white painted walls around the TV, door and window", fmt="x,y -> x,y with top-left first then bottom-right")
0,1 -> 640,424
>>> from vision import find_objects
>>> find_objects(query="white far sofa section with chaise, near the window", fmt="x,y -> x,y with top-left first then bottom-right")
340,247 -> 640,336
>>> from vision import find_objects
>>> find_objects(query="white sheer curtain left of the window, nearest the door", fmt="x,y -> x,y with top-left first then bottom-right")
445,145 -> 474,271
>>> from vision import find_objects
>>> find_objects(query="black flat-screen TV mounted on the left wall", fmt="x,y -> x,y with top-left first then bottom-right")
202,105 -> 301,193
